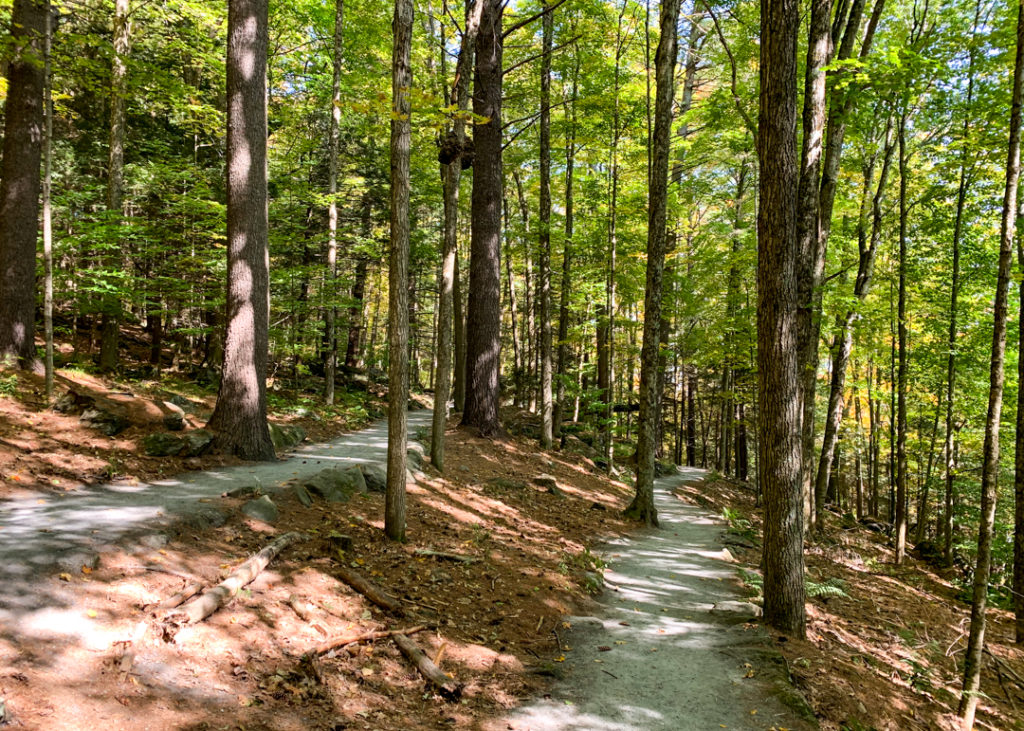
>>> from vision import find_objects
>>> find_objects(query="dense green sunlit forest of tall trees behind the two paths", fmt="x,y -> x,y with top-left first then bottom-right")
0,0 -> 1024,729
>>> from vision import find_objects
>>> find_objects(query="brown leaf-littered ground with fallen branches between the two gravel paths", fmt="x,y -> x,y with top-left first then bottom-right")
0,409 -> 630,731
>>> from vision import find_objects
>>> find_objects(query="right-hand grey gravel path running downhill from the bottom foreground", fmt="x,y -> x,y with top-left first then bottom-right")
495,469 -> 811,731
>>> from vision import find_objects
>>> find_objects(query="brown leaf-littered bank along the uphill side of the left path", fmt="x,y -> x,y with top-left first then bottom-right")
0,369 -> 383,500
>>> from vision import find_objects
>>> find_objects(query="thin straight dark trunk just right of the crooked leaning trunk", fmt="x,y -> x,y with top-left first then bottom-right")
893,109 -> 909,565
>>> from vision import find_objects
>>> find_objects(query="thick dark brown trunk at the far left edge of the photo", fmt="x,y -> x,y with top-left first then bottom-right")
0,0 -> 50,368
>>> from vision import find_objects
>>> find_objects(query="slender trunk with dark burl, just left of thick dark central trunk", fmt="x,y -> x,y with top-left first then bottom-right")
430,3 -> 482,472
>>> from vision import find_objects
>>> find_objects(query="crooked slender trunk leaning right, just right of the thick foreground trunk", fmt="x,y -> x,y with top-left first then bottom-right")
814,125 -> 895,532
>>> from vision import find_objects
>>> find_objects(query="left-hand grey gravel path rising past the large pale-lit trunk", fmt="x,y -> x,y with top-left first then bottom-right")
0,411 -> 431,634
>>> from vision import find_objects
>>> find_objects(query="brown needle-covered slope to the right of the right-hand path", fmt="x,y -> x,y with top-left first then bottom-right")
678,479 -> 1024,731
